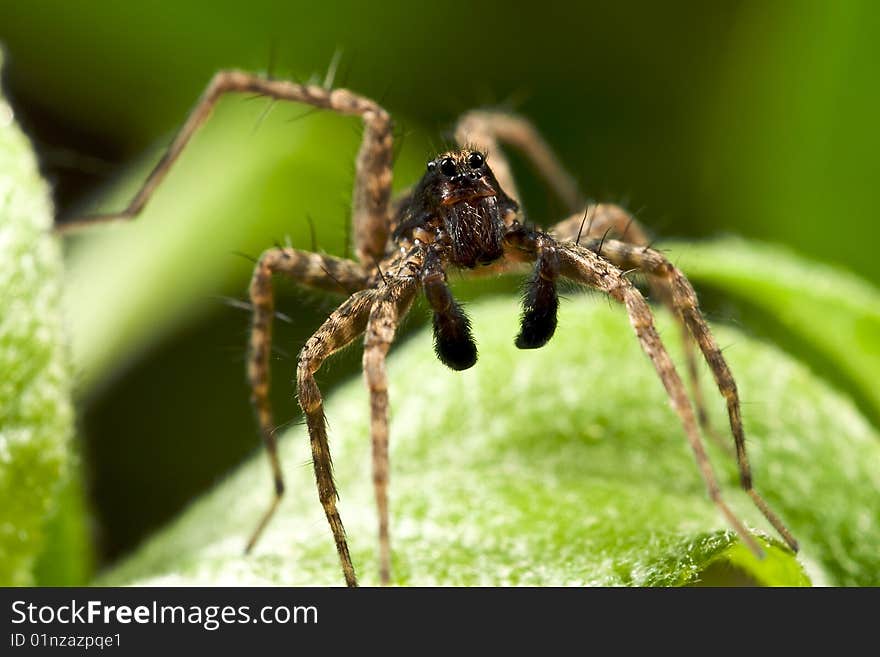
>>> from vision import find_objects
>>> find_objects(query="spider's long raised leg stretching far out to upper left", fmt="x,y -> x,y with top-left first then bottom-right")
56,70 -> 393,263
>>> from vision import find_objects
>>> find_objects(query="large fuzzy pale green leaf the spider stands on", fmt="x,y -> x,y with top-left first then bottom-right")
100,296 -> 880,585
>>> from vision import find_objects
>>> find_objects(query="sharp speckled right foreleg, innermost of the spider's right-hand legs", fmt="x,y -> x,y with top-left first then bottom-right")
507,227 -> 763,556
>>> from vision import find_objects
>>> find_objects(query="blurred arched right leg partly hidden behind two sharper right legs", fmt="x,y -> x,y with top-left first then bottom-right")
549,203 -> 734,456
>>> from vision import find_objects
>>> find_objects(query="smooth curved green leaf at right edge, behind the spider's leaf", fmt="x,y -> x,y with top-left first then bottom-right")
667,238 -> 880,426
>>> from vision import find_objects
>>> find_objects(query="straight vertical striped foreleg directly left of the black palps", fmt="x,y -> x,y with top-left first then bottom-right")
363,279 -> 417,586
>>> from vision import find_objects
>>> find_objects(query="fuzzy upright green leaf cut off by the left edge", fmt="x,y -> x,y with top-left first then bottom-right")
0,62 -> 82,586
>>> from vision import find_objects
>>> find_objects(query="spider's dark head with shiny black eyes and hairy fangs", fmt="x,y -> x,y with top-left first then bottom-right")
398,148 -> 518,268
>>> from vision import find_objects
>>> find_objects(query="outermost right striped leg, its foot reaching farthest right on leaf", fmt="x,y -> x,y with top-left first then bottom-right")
584,240 -> 798,552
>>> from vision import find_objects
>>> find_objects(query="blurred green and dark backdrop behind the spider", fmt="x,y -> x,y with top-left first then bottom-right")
0,0 -> 880,576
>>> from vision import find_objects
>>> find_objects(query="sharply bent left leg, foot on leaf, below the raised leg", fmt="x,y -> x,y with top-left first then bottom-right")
245,248 -> 366,568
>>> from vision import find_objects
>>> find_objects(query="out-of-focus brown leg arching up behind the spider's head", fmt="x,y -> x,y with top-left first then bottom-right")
455,110 -> 581,211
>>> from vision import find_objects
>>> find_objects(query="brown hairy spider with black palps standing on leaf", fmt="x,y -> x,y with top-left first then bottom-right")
59,70 -> 798,586
